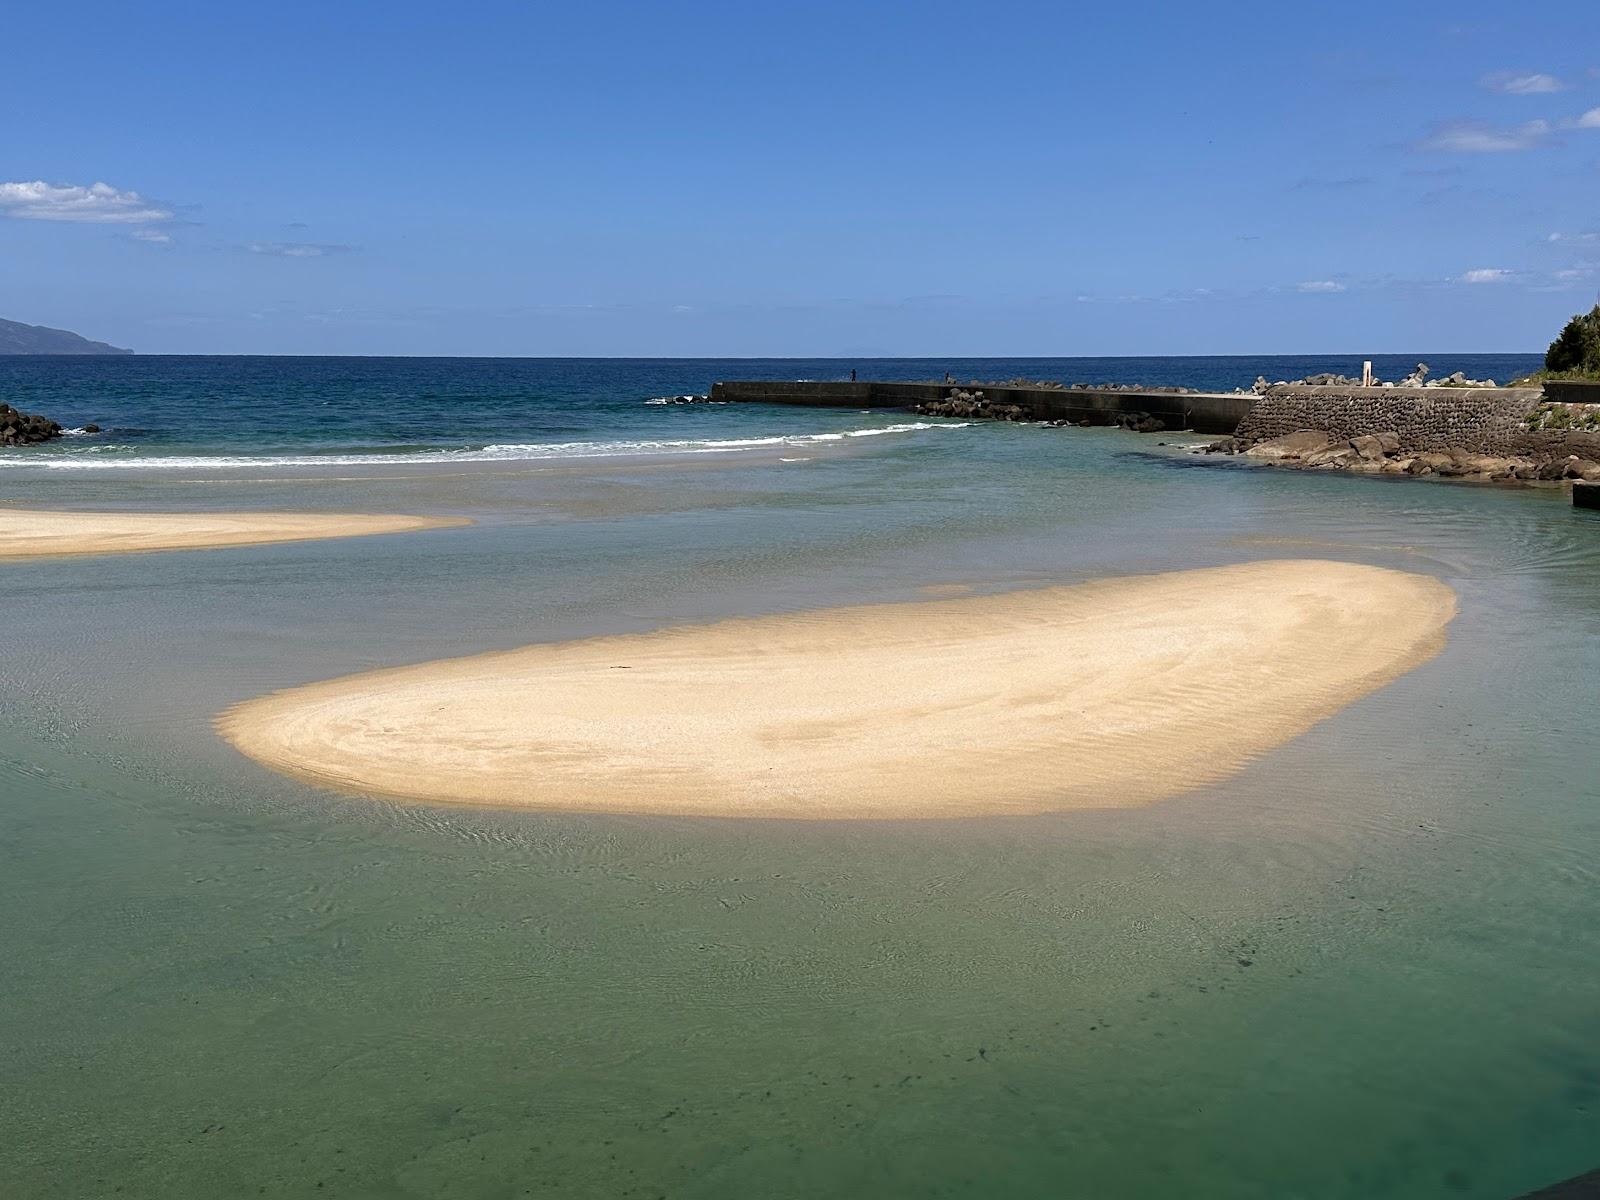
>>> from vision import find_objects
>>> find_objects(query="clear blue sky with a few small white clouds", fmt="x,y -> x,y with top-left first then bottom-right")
0,0 -> 1600,357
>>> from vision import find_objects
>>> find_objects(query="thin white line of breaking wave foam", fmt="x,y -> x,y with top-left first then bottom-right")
0,421 -> 971,470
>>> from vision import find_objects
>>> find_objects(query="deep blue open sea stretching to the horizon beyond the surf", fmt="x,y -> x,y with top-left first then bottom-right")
0,354 -> 1541,469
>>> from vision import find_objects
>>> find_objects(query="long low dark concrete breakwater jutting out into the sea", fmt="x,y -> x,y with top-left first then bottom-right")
710,379 -> 1258,434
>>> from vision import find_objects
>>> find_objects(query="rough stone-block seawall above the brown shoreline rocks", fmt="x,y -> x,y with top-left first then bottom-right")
1235,387 -> 1600,462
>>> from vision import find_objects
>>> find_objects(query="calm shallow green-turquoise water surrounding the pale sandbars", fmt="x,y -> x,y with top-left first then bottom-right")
0,360 -> 1600,1198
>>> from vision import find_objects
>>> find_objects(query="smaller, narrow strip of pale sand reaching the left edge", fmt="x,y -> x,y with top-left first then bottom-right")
0,509 -> 470,558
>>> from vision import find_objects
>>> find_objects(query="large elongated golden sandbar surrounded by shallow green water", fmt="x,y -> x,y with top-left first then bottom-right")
218,560 -> 1454,818
